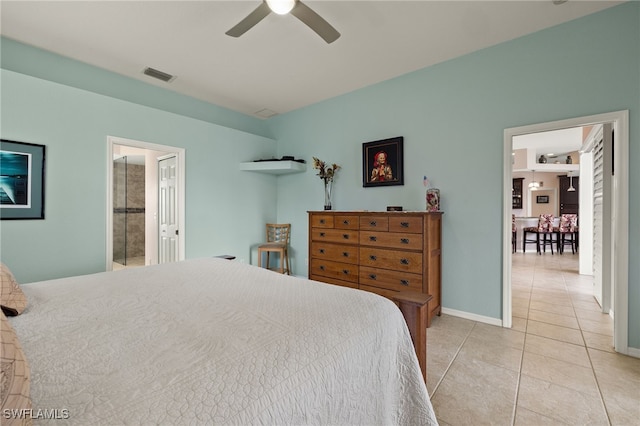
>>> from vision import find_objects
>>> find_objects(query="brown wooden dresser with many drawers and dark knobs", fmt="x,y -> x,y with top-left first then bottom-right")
308,211 -> 442,327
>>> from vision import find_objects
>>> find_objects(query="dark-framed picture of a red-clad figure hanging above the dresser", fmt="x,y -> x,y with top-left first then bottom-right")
362,136 -> 404,188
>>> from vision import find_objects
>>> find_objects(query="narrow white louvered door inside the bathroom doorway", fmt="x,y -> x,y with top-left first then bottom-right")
158,155 -> 180,263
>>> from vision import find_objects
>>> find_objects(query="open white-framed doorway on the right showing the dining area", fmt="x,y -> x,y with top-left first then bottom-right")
503,111 -> 629,353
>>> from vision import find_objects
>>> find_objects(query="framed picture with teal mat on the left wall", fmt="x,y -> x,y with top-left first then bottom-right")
0,139 -> 45,220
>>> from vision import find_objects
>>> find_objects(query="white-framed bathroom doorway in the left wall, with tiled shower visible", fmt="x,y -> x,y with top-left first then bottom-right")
106,137 -> 184,271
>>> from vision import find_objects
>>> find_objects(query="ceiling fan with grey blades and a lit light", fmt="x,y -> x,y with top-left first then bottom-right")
225,0 -> 340,43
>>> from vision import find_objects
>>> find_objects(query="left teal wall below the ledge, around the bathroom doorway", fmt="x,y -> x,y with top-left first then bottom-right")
0,69 -> 276,283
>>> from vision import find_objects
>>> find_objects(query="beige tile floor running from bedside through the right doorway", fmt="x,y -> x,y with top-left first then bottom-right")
427,252 -> 640,426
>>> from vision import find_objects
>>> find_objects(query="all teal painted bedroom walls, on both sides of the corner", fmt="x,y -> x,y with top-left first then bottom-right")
0,2 -> 640,348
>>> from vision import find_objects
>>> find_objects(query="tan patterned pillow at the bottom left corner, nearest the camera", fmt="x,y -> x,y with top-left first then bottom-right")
0,312 -> 32,426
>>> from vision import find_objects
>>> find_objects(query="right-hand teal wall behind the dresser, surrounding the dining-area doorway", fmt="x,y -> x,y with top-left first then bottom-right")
269,2 -> 640,348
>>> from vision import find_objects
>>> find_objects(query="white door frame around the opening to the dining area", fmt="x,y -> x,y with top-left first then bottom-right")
502,110 -> 638,356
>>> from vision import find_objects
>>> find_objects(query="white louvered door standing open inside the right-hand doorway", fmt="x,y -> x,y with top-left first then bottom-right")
592,123 -> 613,313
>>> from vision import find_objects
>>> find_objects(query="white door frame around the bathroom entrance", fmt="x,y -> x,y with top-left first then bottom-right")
105,136 -> 186,271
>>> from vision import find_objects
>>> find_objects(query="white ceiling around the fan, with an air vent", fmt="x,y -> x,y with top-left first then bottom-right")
0,0 -> 622,115
